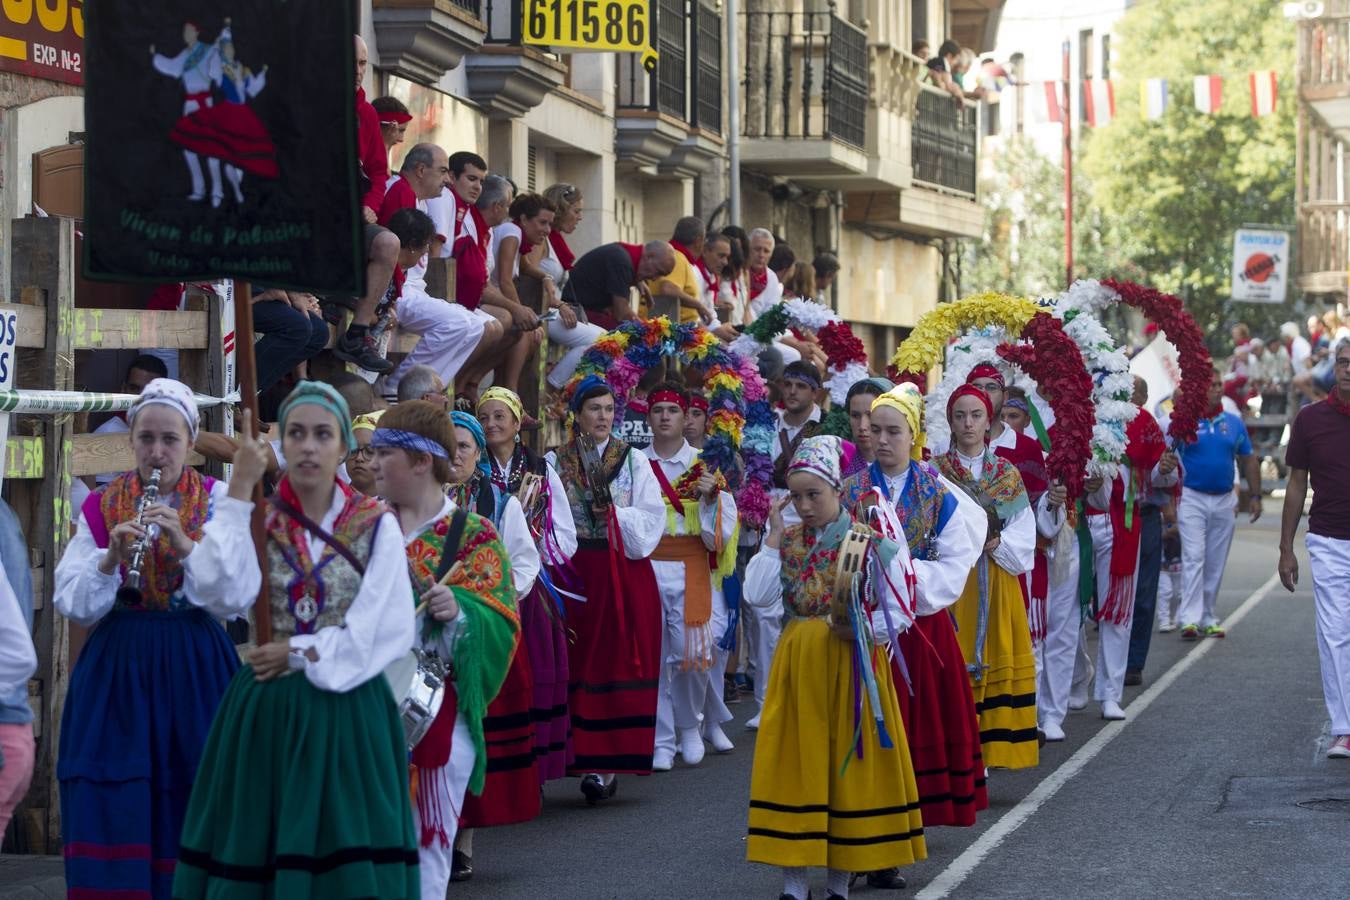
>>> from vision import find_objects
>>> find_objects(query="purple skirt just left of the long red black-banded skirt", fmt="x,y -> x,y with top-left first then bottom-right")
520,583 -> 572,784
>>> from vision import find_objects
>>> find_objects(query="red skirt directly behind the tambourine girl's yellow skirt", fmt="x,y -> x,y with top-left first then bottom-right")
891,611 -> 990,828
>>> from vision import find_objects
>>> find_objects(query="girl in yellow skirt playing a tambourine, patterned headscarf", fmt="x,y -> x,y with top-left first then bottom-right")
745,436 -> 928,900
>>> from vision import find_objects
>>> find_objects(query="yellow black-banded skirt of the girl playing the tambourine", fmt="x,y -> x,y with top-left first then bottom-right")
745,619 -> 927,872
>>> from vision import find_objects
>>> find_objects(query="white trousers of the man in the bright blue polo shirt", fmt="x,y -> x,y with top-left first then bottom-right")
1177,487 -> 1238,627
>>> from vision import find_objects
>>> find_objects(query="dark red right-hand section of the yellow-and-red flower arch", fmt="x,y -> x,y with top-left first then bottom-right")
998,313 -> 1096,497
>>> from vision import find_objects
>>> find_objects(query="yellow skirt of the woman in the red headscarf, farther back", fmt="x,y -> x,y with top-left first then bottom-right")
952,561 -> 1040,769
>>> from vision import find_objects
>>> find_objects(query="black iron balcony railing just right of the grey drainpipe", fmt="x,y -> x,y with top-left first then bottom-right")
741,3 -> 867,148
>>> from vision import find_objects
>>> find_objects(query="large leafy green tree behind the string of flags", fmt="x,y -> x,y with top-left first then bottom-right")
1081,0 -> 1296,351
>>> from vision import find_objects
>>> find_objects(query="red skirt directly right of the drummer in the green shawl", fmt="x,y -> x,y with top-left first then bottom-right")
459,646 -> 540,828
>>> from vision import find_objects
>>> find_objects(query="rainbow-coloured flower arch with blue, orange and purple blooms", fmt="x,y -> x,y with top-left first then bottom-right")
567,316 -> 775,528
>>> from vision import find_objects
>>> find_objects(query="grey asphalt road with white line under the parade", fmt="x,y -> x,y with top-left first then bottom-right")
475,520 -> 1350,900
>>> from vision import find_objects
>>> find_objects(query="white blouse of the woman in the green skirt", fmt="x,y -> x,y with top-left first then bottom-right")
291,493 -> 414,694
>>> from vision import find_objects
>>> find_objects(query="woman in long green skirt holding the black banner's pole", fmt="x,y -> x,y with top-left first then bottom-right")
173,382 -> 419,900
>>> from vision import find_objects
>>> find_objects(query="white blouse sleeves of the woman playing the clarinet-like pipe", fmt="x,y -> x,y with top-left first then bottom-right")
53,482 -> 262,627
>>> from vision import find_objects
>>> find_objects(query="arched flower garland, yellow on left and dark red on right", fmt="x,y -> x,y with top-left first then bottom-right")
892,293 -> 1095,495
